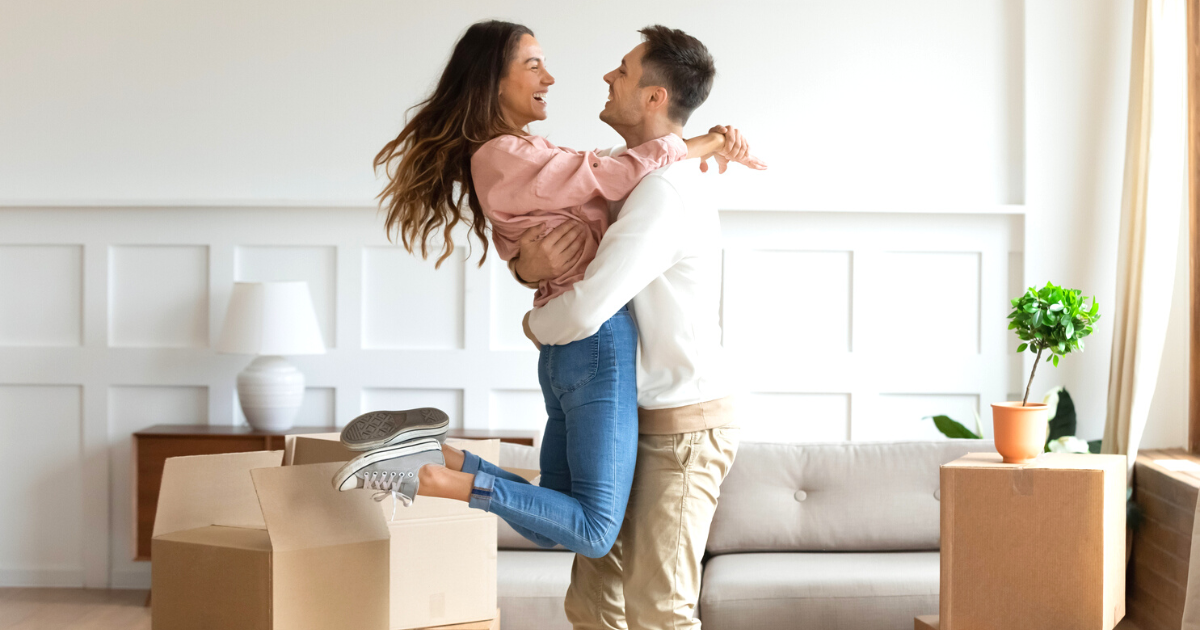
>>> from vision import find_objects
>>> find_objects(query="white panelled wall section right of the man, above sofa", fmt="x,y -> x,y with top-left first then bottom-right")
721,212 -> 1022,442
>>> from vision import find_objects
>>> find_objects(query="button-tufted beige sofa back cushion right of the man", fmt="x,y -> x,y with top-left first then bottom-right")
708,439 -> 992,553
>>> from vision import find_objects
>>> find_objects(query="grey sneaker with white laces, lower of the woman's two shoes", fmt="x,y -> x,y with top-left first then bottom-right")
334,438 -> 445,505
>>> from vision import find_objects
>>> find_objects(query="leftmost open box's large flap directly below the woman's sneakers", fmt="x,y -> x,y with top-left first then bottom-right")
251,462 -> 389,551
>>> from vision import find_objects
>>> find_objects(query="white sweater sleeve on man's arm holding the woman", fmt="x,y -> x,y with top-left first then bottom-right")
529,172 -> 689,346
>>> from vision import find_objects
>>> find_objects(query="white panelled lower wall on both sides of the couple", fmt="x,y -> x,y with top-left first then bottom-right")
0,208 -> 1021,586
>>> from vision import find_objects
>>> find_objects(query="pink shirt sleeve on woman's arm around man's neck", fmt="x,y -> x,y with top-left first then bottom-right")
472,134 -> 688,215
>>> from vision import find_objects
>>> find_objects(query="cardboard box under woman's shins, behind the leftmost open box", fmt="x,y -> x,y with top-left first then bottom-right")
284,433 -> 500,630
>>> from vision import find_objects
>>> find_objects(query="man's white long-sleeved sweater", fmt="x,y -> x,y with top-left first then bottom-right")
529,149 -> 731,409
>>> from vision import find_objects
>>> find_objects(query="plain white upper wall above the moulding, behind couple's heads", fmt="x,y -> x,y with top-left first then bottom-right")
0,0 -> 1024,211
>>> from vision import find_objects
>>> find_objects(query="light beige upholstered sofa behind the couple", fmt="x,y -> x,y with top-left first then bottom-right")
498,440 -> 992,630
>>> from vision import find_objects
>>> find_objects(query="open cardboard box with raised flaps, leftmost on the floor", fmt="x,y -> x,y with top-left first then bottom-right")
151,451 -> 390,630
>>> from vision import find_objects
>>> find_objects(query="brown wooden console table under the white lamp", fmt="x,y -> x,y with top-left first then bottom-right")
132,425 -> 536,560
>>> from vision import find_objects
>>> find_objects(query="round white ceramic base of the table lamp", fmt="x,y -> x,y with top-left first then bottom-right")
238,356 -> 304,431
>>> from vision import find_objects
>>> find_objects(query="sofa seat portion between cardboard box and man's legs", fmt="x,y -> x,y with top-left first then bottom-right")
496,551 -> 575,630
